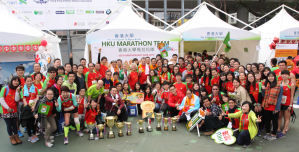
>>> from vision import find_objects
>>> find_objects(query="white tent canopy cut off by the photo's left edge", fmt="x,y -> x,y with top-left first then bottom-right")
0,2 -> 61,59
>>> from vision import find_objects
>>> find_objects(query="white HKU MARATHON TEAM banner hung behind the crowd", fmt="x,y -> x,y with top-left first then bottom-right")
91,41 -> 178,65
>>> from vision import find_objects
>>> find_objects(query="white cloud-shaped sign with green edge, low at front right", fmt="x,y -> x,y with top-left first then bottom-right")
211,128 -> 236,145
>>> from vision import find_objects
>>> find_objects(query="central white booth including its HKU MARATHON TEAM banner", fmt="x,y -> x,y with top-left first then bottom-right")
84,1 -> 181,67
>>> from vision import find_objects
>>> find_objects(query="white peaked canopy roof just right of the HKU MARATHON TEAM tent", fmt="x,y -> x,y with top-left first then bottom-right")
177,3 -> 260,41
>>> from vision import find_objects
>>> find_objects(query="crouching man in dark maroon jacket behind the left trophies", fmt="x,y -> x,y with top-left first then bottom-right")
105,86 -> 127,122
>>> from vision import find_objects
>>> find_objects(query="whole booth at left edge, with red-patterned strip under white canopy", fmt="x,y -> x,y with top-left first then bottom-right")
0,2 -> 61,81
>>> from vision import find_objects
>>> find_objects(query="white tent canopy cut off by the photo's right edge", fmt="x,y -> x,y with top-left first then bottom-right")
256,5 -> 299,66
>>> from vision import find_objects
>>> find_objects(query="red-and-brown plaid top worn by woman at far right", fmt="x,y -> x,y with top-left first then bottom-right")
262,82 -> 280,107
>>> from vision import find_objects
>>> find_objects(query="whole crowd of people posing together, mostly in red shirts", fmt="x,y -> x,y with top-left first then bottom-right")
0,49 -> 299,148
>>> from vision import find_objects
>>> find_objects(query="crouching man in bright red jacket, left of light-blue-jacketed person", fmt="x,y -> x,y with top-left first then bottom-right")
161,85 -> 185,117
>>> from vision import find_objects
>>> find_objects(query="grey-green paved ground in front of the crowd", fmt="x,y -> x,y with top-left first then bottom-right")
0,92 -> 299,152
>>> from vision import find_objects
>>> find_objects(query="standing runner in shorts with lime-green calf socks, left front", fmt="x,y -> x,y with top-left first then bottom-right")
55,86 -> 83,145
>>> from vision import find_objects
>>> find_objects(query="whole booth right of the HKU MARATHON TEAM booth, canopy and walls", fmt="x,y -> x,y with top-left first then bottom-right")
172,2 -> 260,65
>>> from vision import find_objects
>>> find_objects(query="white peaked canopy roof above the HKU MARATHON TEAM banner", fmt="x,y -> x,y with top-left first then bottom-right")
84,1 -> 181,63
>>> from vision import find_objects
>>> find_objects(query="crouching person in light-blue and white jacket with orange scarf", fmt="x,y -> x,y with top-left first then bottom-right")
177,88 -> 200,122
